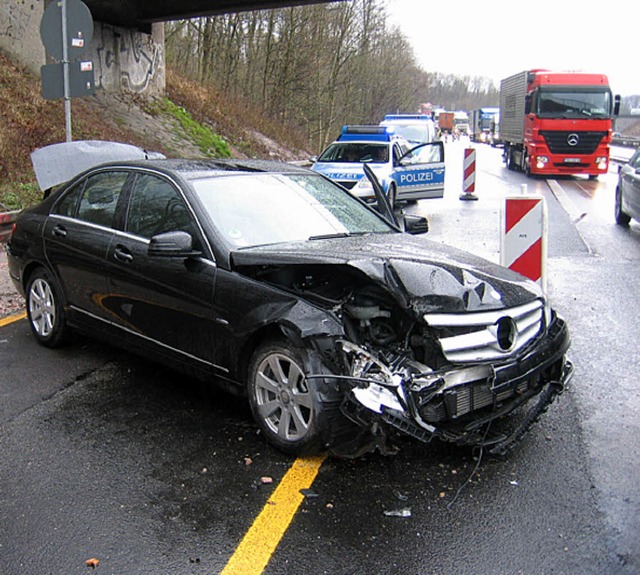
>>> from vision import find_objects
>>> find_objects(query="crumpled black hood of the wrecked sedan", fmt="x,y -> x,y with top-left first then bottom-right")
232,233 -> 543,313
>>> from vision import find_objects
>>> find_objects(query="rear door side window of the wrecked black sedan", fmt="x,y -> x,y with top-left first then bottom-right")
76,172 -> 129,227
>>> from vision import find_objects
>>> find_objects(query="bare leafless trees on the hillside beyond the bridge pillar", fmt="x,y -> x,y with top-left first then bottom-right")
165,0 -> 498,150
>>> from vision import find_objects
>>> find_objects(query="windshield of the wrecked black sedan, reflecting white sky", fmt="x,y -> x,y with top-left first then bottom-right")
193,173 -> 397,248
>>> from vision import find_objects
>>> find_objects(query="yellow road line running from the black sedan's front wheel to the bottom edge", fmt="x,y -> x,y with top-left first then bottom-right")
220,455 -> 326,575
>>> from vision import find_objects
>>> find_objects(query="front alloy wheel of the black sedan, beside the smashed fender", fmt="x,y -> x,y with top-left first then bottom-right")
247,342 -> 321,455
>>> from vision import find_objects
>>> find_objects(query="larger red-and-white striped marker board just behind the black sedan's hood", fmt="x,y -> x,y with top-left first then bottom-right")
500,184 -> 547,290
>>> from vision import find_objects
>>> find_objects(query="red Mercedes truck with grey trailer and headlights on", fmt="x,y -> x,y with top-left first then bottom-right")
500,70 -> 620,179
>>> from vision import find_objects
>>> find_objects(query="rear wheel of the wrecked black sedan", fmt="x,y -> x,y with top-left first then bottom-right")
26,268 -> 70,347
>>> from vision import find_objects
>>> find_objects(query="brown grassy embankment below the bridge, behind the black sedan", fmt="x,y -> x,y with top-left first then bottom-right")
0,52 -> 310,211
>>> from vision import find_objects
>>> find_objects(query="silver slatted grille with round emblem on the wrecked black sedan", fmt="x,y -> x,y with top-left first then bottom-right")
424,300 -> 544,363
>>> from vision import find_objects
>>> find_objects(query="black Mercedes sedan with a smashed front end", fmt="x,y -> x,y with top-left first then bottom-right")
8,145 -> 572,456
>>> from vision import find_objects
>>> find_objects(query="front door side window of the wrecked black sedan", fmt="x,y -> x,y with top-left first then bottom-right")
126,174 -> 199,246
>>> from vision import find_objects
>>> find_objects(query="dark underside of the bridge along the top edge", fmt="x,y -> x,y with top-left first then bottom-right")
84,0 -> 335,31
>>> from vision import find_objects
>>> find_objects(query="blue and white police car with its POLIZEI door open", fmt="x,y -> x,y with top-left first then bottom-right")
311,126 -> 444,207
